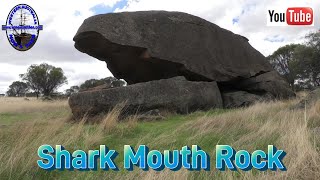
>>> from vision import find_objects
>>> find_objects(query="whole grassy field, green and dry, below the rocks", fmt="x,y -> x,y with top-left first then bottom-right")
0,98 -> 320,179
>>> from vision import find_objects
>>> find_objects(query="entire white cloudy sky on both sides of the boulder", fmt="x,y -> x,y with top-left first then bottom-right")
0,0 -> 320,93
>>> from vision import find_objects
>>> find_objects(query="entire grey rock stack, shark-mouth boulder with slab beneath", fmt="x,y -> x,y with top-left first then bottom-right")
69,11 -> 294,117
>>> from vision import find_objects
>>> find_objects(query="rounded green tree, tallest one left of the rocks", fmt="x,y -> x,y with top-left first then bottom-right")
20,63 -> 67,97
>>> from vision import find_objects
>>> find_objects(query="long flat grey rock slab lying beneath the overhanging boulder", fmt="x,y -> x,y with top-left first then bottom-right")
69,77 -> 223,118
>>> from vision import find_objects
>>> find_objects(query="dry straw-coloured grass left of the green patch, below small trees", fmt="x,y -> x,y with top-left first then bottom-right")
0,98 -> 136,179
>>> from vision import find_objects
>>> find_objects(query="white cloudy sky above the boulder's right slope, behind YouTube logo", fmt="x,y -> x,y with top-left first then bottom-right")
117,0 -> 320,56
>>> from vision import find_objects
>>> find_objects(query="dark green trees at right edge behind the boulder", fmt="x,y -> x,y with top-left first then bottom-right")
267,31 -> 320,91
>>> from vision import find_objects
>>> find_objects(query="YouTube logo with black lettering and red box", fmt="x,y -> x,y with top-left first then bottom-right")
267,7 -> 314,26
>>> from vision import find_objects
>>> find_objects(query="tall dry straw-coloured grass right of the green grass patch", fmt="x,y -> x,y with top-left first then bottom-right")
143,100 -> 320,179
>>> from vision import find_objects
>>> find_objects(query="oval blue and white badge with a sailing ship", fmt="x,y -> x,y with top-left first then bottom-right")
2,4 -> 43,51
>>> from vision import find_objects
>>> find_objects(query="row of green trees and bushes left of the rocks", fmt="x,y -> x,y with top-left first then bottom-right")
6,63 -> 126,98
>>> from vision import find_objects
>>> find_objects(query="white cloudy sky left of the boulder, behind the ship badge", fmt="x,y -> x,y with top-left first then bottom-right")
0,0 -> 119,93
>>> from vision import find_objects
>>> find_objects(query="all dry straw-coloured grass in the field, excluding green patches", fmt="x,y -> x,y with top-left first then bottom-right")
0,96 -> 320,179
